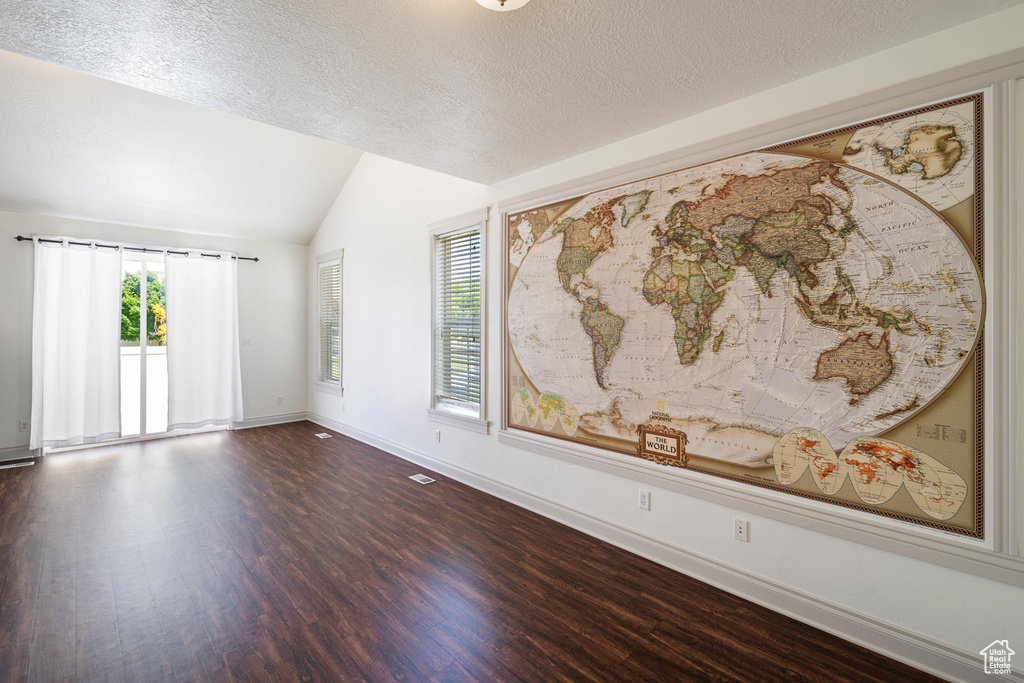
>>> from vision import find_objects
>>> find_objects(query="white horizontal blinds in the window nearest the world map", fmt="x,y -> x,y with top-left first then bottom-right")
434,227 -> 481,411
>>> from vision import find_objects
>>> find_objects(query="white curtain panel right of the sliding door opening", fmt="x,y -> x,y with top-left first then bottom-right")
165,252 -> 242,431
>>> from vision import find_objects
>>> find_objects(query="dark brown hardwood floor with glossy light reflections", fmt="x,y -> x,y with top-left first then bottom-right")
0,423 -> 934,682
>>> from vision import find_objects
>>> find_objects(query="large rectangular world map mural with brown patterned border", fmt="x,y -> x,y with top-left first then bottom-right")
503,93 -> 985,538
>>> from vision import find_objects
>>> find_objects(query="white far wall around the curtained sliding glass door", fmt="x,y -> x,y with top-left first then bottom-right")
0,211 -> 308,450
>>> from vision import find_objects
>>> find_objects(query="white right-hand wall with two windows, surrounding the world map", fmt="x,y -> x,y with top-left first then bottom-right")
309,8 -> 1024,671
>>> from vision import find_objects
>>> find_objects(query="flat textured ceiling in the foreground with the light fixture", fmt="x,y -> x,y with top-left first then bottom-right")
0,0 -> 1021,182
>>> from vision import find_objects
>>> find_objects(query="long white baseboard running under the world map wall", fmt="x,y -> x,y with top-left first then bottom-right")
307,413 -> 1024,683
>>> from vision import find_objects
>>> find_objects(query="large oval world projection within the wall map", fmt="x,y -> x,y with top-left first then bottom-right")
508,153 -> 983,458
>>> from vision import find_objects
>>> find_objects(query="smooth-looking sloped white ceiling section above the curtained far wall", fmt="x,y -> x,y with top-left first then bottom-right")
0,50 -> 359,244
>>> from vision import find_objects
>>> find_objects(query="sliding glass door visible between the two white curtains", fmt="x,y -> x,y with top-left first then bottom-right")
121,252 -> 167,437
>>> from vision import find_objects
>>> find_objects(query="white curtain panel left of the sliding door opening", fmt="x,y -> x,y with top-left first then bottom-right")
30,238 -> 121,449
